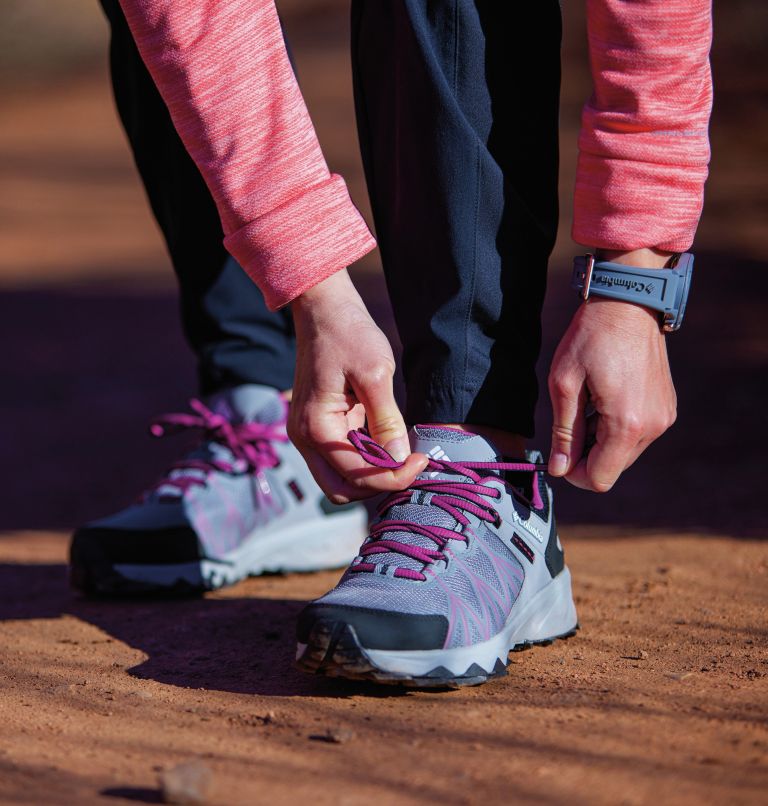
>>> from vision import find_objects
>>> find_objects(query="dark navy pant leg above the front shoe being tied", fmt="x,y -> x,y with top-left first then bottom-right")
352,0 -> 561,435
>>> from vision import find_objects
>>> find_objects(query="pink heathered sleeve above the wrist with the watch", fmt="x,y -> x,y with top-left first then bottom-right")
573,0 -> 712,252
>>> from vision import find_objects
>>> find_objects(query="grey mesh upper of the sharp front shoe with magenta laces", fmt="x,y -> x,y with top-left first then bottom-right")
302,427 -> 546,647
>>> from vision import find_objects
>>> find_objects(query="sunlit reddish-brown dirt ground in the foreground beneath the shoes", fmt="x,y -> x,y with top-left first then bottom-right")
0,529 -> 768,804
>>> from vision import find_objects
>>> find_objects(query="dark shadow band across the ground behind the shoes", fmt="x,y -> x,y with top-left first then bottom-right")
0,254 -> 768,536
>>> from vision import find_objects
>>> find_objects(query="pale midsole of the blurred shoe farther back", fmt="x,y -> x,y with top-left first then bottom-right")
115,507 -> 368,585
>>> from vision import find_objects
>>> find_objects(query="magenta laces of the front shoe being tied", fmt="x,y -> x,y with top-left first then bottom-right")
348,430 -> 547,581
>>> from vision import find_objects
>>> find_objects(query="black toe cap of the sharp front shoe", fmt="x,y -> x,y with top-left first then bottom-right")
297,602 -> 448,650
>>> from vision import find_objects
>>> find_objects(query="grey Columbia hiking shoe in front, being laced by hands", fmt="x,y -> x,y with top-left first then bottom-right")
297,426 -> 577,687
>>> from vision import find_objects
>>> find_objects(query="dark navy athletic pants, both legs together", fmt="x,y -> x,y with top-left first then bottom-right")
103,0 -> 561,434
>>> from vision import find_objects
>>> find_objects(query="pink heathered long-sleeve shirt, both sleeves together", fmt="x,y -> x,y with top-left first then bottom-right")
120,0 -> 712,309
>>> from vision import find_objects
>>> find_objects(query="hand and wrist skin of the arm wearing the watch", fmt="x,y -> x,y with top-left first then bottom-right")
549,250 -> 677,492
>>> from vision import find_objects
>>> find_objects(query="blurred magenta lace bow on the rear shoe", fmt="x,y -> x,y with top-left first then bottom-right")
149,399 -> 288,495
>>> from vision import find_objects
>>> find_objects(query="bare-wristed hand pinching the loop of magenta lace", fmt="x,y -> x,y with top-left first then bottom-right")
288,271 -> 427,504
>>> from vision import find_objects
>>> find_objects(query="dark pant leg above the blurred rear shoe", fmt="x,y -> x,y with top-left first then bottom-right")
102,0 -> 295,394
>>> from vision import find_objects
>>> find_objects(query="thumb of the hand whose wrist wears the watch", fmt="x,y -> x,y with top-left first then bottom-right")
549,376 -> 586,476
